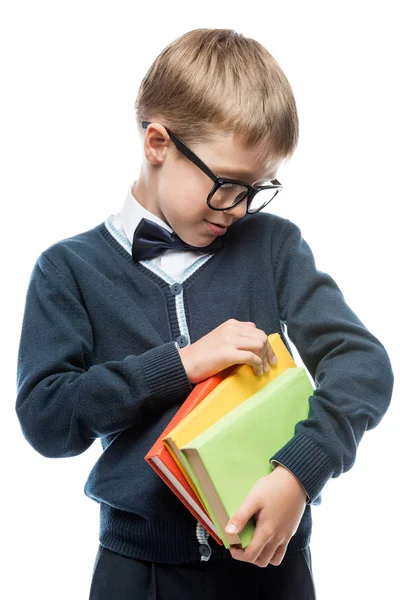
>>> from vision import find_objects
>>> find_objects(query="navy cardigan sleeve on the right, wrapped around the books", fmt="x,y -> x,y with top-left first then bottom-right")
270,220 -> 394,504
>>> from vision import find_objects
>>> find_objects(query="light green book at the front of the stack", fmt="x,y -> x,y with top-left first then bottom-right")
182,367 -> 314,548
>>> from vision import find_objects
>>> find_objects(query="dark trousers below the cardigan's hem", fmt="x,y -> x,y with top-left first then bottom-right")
89,545 -> 316,600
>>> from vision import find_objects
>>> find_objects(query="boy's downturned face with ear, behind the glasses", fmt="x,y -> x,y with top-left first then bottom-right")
133,123 -> 283,247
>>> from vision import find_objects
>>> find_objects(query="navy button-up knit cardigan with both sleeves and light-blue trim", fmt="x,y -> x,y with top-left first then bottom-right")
16,212 -> 394,563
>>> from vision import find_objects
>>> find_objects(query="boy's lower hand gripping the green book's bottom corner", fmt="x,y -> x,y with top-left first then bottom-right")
225,465 -> 307,567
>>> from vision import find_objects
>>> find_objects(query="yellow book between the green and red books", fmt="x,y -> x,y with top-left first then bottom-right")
163,333 -> 297,493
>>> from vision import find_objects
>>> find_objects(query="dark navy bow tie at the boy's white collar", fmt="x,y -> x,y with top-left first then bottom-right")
132,219 -> 224,261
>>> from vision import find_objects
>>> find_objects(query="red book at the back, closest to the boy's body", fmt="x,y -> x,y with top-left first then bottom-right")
144,365 -> 236,546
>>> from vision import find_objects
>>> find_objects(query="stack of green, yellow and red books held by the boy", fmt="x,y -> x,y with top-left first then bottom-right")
145,333 -> 314,548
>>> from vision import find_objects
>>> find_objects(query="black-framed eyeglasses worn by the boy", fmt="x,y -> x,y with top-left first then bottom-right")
142,121 -> 283,214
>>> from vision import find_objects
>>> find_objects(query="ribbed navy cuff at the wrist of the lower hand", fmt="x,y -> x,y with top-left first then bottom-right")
269,433 -> 333,504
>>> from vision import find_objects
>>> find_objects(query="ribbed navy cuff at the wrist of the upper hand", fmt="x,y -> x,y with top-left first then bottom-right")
139,342 -> 193,405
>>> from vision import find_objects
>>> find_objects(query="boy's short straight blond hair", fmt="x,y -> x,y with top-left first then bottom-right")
135,29 -> 299,164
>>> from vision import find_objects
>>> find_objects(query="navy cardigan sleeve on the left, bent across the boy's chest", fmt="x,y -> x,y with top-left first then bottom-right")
16,253 -> 192,457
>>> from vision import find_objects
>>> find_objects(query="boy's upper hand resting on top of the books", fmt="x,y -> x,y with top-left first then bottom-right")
179,319 -> 276,383
